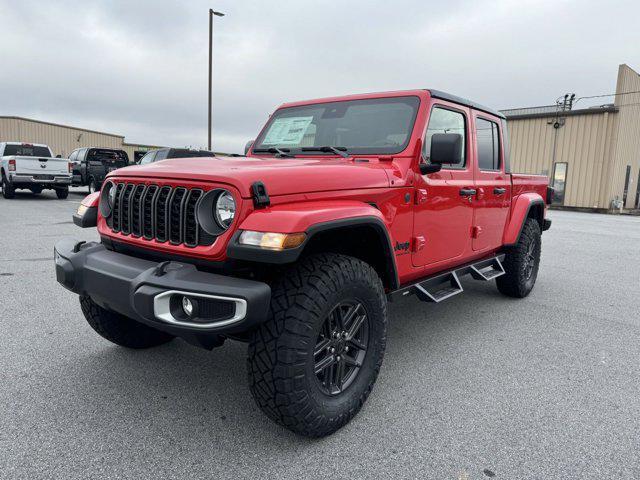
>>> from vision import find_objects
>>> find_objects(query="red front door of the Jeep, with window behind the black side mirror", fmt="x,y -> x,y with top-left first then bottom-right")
413,102 -> 474,267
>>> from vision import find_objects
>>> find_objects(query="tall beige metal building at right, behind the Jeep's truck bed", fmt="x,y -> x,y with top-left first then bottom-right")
502,65 -> 640,211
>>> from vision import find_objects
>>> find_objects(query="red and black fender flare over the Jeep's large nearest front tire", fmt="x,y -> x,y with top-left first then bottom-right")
227,201 -> 398,288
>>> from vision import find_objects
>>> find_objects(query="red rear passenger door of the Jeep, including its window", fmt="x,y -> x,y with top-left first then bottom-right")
471,115 -> 511,251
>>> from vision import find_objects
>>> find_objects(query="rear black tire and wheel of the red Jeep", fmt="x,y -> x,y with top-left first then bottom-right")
496,218 -> 542,298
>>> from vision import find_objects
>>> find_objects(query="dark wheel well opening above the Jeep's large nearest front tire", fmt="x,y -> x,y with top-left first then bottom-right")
303,224 -> 398,290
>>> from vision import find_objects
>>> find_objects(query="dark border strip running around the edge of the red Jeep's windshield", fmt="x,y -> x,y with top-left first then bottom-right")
251,94 -> 422,157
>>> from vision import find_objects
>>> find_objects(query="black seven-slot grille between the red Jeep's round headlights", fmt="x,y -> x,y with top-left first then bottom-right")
107,183 -> 215,247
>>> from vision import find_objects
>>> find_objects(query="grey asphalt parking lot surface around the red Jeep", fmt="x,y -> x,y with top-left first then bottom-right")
0,188 -> 640,479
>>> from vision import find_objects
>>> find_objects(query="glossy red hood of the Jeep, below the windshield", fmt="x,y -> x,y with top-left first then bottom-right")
109,157 -> 391,198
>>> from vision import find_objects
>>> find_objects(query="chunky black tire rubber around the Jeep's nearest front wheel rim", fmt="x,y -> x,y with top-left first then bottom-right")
247,254 -> 387,437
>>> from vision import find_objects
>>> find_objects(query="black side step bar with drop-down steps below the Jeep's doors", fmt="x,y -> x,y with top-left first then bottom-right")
389,254 -> 505,303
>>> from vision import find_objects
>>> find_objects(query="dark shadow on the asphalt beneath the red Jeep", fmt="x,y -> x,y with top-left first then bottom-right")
50,280 -> 508,448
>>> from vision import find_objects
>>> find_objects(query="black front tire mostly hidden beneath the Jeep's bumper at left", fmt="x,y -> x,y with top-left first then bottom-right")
80,296 -> 174,349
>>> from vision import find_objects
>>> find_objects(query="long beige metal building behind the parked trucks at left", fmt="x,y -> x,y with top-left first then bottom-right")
0,116 -> 162,162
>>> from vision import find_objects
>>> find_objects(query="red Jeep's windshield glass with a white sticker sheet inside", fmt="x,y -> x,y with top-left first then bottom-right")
253,97 -> 420,155
